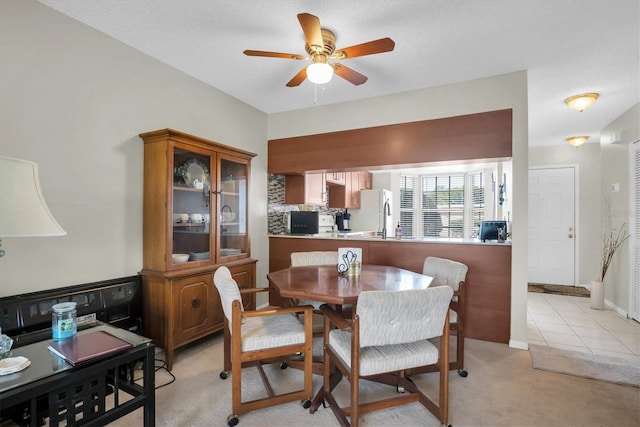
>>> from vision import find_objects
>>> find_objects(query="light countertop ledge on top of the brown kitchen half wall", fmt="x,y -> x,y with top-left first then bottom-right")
269,231 -> 511,246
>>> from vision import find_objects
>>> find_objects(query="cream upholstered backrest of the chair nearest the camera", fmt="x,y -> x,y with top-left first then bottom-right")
356,286 -> 453,347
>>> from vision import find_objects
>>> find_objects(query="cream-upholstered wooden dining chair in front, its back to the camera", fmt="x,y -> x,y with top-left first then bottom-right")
320,286 -> 453,426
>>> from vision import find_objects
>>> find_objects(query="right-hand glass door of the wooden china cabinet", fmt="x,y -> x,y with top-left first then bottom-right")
218,156 -> 249,258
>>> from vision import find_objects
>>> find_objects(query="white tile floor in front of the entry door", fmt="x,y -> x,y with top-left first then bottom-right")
527,292 -> 640,362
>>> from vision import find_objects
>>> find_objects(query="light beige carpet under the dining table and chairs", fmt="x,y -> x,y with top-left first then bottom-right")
109,334 -> 640,427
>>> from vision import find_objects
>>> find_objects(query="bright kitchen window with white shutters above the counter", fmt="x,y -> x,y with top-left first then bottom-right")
400,171 -> 485,238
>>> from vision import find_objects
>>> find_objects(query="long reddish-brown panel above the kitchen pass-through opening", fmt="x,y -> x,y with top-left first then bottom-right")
267,109 -> 513,175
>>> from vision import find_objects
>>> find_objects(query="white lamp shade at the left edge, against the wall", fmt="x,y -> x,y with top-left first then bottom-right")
0,157 -> 67,238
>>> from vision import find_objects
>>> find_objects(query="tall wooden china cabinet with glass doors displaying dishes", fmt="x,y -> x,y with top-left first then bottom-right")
140,129 -> 256,370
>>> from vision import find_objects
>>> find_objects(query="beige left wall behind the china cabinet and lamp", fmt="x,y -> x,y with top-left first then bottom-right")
0,0 -> 268,296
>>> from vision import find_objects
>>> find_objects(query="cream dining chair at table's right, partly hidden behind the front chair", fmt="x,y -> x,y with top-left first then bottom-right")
414,256 -> 469,377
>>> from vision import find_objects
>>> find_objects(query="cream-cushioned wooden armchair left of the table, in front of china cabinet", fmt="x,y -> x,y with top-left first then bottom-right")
213,266 -> 313,426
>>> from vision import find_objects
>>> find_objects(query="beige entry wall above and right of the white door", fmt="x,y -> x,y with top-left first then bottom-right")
529,104 -> 640,312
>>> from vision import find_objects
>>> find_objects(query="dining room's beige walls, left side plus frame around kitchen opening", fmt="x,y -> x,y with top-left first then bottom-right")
0,0 -> 528,346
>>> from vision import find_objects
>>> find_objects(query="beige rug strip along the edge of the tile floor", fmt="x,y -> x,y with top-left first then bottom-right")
529,344 -> 640,387
